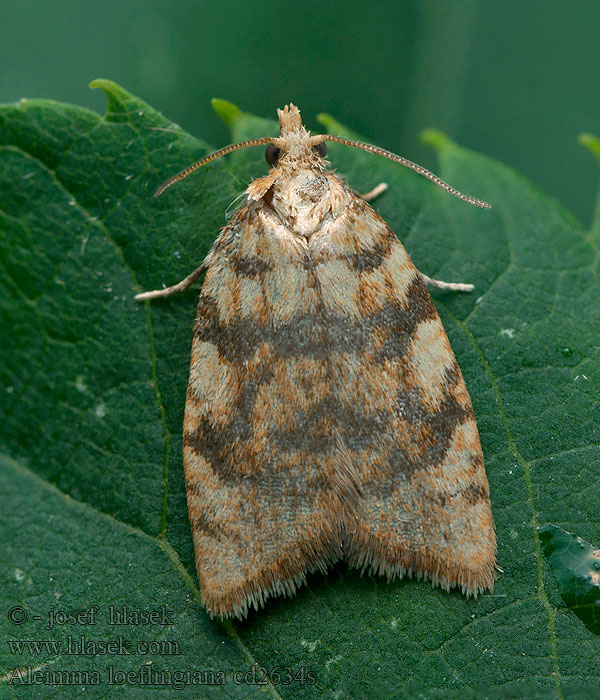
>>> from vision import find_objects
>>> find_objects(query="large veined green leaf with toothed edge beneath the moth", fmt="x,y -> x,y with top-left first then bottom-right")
0,81 -> 600,700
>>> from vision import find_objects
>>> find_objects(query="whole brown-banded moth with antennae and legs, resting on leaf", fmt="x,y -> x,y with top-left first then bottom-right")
136,104 -> 496,618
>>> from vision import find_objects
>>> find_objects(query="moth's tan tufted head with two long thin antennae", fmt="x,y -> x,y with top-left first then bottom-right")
154,103 -> 492,209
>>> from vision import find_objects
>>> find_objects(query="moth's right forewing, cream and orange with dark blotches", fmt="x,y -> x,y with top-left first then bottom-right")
344,207 -> 496,595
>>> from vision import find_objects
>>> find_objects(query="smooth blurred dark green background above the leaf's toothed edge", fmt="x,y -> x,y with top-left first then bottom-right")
0,0 -> 600,224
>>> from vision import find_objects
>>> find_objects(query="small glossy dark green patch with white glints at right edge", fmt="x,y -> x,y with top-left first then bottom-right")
540,525 -> 600,634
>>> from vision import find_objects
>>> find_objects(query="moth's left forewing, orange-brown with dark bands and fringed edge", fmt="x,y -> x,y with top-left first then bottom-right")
183,202 -> 352,617
